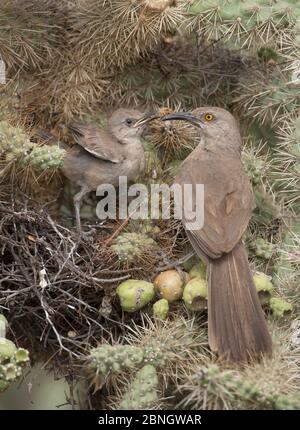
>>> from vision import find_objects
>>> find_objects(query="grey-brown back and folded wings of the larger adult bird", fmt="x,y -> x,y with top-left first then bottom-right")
175,151 -> 255,258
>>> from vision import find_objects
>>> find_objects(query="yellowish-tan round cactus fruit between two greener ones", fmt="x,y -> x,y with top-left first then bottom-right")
154,270 -> 183,302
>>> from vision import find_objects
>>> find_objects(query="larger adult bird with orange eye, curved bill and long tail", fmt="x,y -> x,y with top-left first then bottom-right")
162,107 -> 272,362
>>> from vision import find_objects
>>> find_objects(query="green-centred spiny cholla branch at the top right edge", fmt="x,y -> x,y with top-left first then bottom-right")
188,0 -> 299,46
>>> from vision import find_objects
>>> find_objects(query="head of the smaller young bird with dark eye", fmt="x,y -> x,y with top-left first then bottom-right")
109,109 -> 158,144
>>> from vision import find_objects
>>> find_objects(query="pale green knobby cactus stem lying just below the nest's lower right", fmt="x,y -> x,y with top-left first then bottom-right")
88,345 -> 144,376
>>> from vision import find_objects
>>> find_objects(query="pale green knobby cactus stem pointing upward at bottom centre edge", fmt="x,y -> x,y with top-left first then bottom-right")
118,364 -> 158,410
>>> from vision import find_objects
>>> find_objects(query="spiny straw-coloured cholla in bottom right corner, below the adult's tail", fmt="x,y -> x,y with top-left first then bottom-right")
178,326 -> 300,410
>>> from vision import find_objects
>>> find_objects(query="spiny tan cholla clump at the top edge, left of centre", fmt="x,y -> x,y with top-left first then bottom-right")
70,0 -> 187,72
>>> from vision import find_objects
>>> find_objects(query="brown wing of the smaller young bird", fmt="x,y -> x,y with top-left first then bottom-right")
69,123 -> 124,163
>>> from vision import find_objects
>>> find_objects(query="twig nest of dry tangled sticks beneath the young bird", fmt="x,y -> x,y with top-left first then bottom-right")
0,195 -> 190,364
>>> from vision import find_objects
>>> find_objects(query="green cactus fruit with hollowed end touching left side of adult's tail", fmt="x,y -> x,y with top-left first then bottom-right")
183,278 -> 208,311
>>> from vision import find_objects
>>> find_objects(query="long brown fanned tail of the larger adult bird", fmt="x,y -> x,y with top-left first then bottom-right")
208,243 -> 272,362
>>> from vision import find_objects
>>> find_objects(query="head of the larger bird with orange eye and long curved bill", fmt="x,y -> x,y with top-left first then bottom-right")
161,107 -> 239,144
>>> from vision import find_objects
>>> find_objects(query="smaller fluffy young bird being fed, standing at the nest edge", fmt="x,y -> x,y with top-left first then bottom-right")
40,109 -> 145,230
